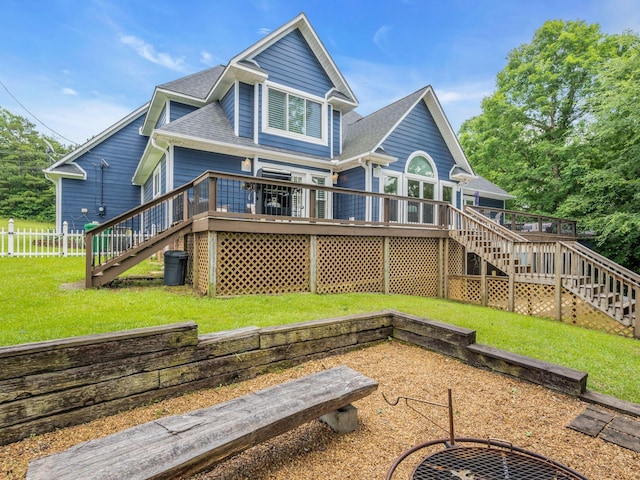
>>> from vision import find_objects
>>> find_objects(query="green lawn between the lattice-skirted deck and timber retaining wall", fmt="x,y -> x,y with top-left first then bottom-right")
0,258 -> 640,403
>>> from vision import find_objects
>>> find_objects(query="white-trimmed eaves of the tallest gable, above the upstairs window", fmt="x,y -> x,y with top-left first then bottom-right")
207,13 -> 358,111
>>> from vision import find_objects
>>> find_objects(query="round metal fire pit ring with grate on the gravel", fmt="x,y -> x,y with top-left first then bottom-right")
386,438 -> 588,480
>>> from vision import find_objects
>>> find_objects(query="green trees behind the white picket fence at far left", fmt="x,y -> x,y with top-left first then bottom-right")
0,107 -> 66,222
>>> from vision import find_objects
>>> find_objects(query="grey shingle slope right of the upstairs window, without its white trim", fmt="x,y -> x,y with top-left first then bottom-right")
340,87 -> 428,159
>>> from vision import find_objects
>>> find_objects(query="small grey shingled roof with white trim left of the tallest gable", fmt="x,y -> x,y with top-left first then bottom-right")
140,65 -> 225,135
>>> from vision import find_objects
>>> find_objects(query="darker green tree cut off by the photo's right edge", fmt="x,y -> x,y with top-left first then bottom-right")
559,33 -> 640,271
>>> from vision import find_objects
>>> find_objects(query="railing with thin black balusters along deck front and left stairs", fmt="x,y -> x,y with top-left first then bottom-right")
86,171 -> 450,278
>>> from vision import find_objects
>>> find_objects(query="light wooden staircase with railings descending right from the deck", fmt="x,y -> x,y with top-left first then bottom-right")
450,208 -> 640,337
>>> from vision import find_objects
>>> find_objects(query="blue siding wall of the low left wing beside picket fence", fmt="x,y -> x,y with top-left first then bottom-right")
60,115 -> 147,229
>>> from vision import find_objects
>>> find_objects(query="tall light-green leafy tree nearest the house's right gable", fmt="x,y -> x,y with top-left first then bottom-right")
460,20 -> 605,214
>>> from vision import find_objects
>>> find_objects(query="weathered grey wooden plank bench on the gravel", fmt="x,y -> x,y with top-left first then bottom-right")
27,366 -> 378,480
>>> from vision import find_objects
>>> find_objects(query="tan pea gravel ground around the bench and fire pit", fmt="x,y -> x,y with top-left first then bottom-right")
0,341 -> 640,480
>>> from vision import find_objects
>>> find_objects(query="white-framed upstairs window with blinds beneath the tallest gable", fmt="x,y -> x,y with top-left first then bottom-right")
262,85 -> 327,145
